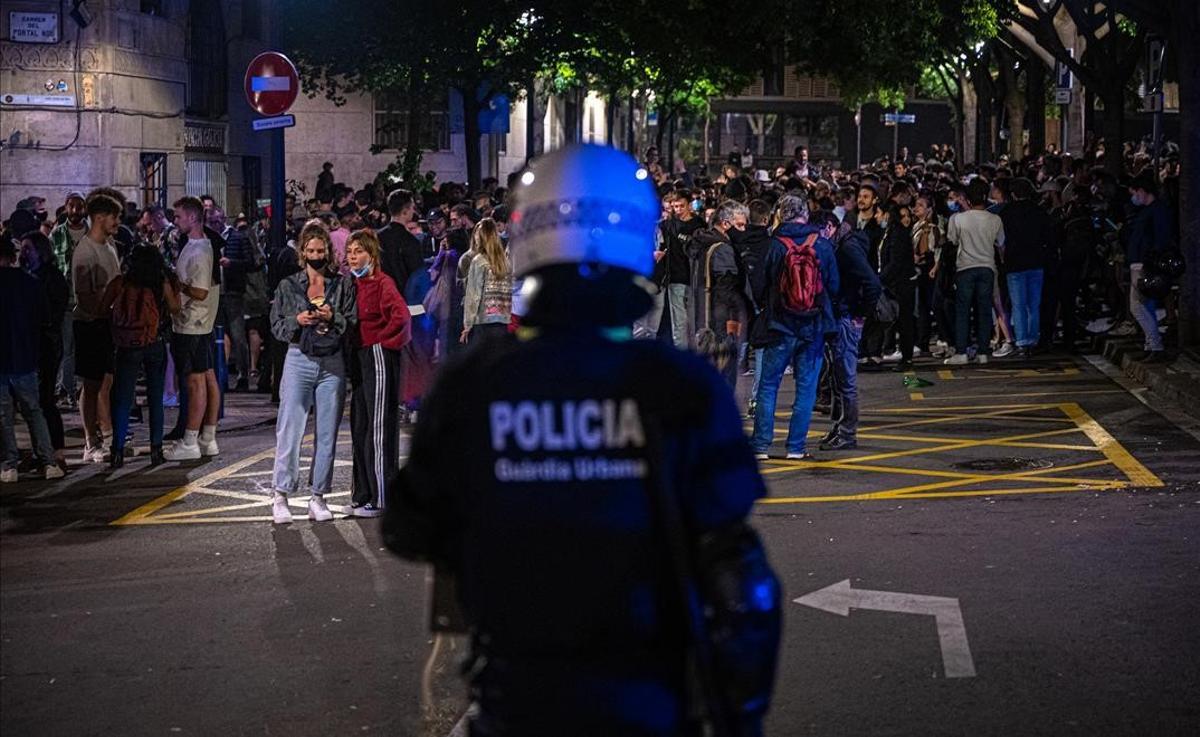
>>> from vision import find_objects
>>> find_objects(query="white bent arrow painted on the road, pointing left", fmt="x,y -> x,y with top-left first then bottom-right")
792,579 -> 976,678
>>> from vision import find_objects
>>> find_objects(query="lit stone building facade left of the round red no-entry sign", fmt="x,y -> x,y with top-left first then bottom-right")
0,0 -> 272,216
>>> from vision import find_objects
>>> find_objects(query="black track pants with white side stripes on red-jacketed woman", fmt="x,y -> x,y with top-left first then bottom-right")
350,344 -> 401,509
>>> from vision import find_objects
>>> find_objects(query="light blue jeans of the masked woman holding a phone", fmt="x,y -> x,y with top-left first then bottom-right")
271,346 -> 346,495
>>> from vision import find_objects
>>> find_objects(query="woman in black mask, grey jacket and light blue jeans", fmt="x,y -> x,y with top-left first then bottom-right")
271,222 -> 358,525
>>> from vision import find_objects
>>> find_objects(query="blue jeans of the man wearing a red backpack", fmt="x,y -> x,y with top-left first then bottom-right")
754,336 -> 824,453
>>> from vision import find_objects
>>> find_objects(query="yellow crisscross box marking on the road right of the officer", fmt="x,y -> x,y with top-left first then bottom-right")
761,395 -> 1164,504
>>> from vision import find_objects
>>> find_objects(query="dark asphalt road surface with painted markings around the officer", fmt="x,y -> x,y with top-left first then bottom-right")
0,356 -> 1200,737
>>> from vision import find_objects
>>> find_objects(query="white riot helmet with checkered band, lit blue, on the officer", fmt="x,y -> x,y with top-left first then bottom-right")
509,144 -> 660,277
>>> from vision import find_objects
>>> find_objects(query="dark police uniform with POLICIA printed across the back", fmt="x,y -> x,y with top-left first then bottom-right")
384,326 -> 779,737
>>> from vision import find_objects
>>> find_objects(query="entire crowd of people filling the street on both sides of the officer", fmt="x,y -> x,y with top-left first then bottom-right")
0,135 -> 1182,484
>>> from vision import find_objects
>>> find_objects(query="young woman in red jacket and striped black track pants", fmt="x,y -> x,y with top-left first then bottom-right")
346,228 -> 413,517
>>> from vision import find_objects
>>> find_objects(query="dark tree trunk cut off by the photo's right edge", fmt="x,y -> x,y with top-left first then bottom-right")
1171,0 -> 1200,348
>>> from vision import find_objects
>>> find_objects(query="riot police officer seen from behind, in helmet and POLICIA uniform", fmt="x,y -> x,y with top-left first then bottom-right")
383,145 -> 780,737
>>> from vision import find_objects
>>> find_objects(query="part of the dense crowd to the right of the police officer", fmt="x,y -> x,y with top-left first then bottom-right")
635,142 -> 1183,460
